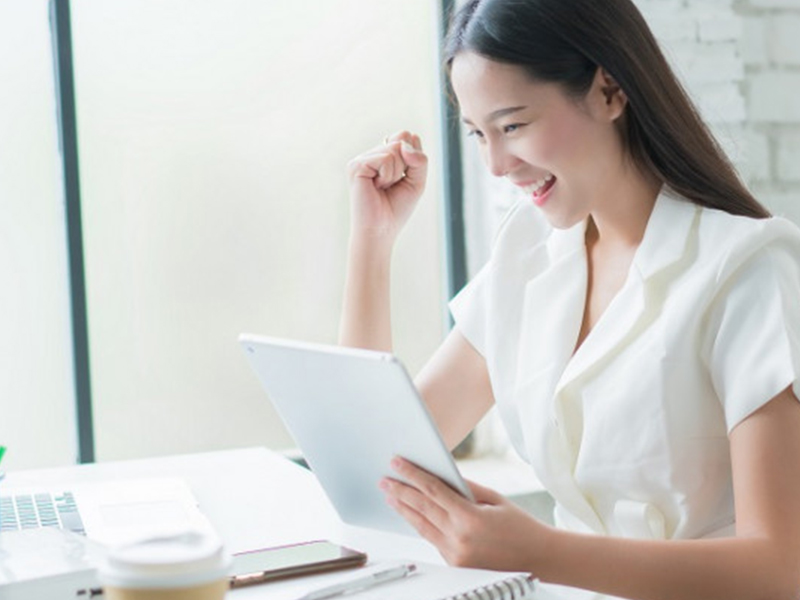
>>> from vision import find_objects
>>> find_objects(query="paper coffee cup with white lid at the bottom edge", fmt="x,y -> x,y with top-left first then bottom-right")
98,531 -> 230,600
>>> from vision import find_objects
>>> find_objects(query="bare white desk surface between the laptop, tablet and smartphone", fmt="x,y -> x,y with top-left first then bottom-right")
3,448 -> 564,600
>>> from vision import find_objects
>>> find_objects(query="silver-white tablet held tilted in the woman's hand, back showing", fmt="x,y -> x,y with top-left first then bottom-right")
239,334 -> 473,535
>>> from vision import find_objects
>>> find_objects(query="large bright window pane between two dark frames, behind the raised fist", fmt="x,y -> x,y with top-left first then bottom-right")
72,0 -> 443,459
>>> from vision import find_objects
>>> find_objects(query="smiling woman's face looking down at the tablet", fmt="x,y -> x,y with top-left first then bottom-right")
451,52 -> 625,228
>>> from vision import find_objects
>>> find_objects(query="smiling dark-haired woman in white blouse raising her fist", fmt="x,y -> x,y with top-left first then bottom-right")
341,0 -> 800,600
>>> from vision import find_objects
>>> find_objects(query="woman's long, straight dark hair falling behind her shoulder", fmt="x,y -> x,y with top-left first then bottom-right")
444,0 -> 770,218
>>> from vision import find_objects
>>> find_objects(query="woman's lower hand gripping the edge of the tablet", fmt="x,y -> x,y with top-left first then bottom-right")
381,458 -> 555,572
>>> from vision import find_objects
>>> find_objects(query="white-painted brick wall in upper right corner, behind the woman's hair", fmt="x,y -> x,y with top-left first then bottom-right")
624,0 -> 800,223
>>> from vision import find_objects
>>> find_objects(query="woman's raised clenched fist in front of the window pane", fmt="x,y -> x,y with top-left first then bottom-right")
347,131 -> 428,244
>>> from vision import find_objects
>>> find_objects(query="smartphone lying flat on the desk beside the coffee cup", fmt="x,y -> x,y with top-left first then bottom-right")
230,540 -> 367,588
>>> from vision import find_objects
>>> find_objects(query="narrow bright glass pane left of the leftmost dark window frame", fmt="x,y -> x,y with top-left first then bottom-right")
0,0 -> 77,468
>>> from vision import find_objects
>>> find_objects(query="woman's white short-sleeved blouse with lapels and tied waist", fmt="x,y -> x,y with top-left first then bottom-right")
450,191 -> 800,596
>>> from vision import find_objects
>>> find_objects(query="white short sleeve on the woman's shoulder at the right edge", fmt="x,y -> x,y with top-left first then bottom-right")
706,232 -> 800,433
